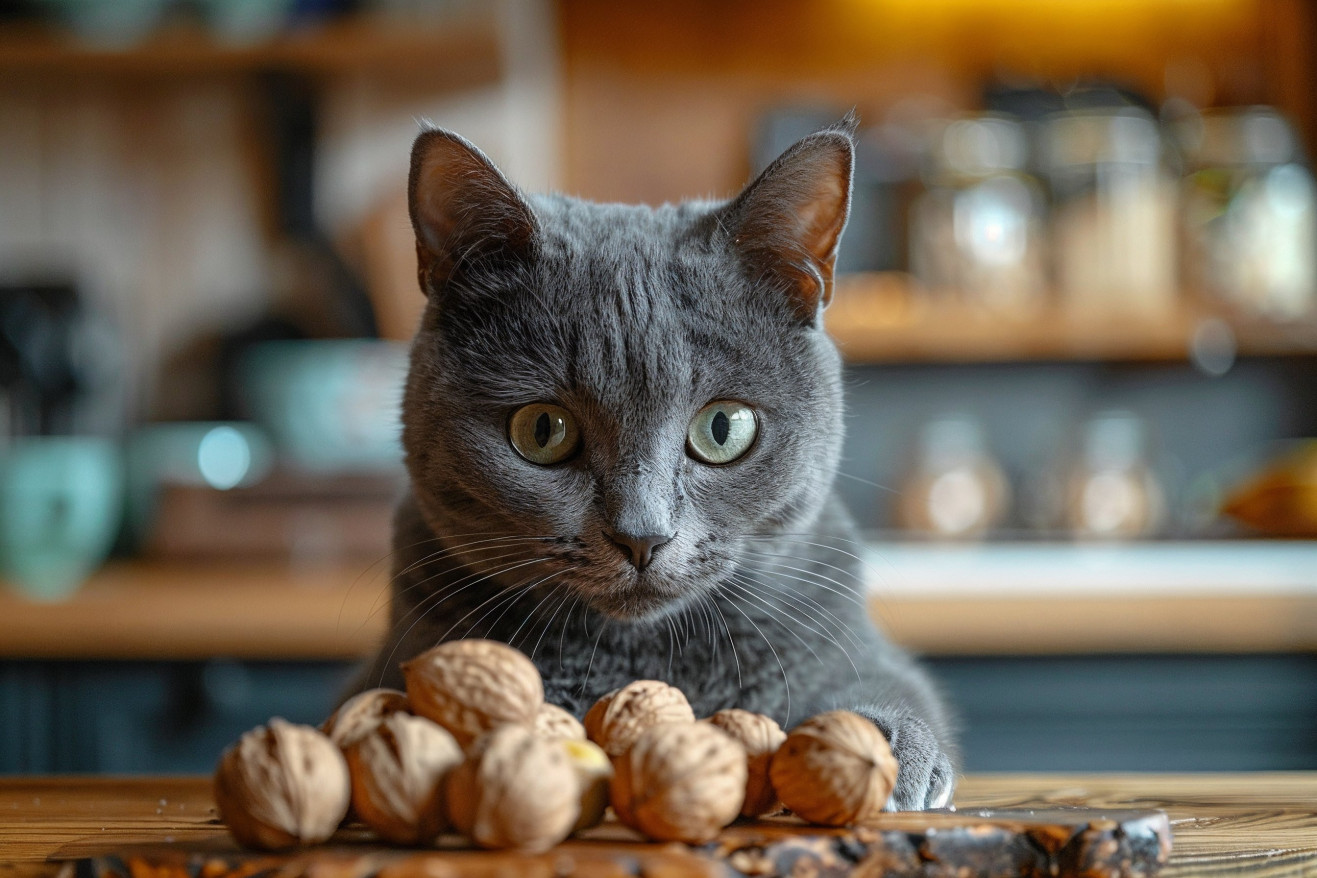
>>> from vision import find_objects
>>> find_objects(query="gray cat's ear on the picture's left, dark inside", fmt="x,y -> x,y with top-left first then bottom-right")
407,129 -> 536,296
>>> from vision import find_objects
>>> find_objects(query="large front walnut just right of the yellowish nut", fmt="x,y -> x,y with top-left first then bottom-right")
611,723 -> 745,844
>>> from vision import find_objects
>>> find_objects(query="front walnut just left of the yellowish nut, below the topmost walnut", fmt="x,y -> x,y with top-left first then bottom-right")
445,725 -> 581,850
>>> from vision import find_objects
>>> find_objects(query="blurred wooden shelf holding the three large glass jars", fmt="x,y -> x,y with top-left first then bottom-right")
826,274 -> 1317,363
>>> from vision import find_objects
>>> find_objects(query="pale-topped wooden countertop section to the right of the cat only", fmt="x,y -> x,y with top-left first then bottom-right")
865,541 -> 1317,656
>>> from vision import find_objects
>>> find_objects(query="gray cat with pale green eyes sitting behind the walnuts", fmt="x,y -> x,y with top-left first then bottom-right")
356,118 -> 955,810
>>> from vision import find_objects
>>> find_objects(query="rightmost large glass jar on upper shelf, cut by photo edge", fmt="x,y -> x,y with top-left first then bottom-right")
1176,107 -> 1317,320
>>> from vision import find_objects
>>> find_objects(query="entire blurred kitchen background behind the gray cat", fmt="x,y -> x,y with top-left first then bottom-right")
0,0 -> 1317,773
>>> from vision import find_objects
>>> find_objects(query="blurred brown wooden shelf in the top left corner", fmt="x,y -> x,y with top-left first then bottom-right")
0,14 -> 499,78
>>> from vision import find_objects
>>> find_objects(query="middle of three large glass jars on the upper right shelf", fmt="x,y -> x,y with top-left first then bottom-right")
1040,108 -> 1179,317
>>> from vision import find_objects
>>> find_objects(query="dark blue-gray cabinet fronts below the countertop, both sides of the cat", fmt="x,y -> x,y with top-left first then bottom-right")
0,656 -> 1317,774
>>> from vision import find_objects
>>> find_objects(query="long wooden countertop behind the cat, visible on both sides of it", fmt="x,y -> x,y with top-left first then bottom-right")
0,542 -> 1317,659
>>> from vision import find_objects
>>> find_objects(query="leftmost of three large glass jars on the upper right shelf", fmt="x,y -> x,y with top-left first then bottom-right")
910,116 -> 1046,311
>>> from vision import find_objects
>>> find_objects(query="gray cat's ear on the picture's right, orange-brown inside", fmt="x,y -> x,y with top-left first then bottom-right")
722,115 -> 856,324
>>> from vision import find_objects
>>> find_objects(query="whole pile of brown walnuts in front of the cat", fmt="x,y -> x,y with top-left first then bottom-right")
215,640 -> 897,850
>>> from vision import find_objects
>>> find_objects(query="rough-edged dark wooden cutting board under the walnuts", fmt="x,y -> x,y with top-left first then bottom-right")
71,808 -> 1171,878
